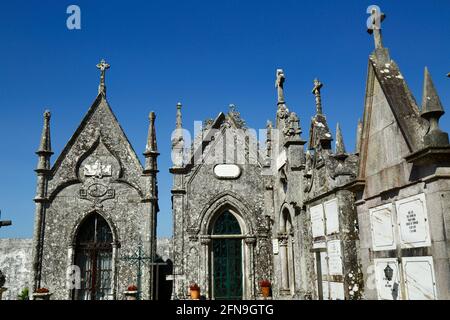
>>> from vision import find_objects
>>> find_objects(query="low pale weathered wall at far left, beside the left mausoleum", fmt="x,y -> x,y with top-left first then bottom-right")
0,239 -> 32,300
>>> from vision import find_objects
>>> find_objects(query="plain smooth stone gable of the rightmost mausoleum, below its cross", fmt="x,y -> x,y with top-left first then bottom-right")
359,56 -> 426,197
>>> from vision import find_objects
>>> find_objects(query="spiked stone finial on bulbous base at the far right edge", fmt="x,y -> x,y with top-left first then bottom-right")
420,67 -> 449,146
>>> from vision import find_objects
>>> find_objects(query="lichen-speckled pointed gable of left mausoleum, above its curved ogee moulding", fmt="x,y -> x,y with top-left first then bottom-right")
48,94 -> 143,196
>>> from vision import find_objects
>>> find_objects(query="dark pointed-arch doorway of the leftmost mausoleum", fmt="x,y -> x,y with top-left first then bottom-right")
73,213 -> 113,300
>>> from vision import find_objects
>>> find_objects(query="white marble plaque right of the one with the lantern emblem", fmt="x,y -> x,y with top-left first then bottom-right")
402,257 -> 437,300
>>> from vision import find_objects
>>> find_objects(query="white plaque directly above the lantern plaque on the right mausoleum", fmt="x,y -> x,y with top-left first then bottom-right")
369,203 -> 396,251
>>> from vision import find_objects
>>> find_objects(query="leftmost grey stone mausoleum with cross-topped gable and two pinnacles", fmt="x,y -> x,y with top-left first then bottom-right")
31,61 -> 158,300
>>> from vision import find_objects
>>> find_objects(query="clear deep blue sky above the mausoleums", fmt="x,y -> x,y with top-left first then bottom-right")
0,0 -> 450,238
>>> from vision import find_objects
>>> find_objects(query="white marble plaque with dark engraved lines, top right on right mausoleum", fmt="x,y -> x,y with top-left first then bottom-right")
395,193 -> 431,248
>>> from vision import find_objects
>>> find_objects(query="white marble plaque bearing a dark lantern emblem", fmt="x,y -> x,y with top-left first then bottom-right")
374,258 -> 402,300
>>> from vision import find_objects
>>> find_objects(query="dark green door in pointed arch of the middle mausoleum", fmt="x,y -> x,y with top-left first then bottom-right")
211,211 -> 243,300
